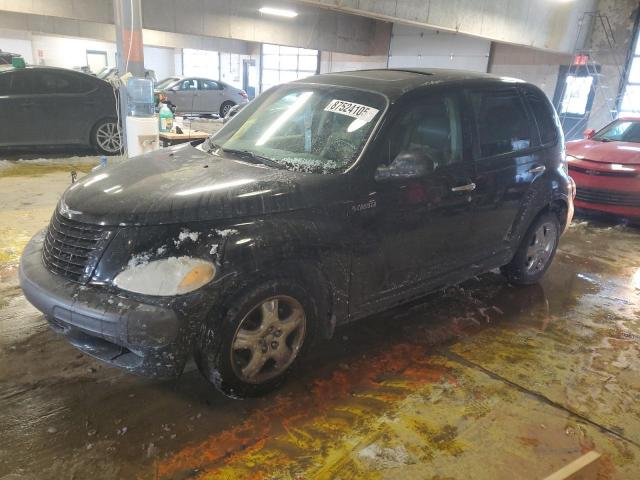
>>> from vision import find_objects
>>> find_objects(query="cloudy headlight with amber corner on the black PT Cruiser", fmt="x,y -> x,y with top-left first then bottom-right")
113,257 -> 216,296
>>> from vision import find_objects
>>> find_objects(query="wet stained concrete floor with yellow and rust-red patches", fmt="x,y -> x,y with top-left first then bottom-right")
0,157 -> 640,480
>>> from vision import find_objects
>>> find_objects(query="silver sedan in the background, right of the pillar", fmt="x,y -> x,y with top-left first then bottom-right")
156,77 -> 249,117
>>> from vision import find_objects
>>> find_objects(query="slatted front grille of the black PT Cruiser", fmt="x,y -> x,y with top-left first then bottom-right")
42,210 -> 109,283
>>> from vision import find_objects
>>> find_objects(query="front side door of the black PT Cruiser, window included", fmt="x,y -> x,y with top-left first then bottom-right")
351,94 -> 474,313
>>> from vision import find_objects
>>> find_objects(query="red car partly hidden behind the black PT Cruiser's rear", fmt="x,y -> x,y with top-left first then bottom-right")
567,117 -> 640,220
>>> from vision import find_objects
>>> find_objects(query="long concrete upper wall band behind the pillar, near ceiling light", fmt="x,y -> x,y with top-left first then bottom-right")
0,0 -> 391,55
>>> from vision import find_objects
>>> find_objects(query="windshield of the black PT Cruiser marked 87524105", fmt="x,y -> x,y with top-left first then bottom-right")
210,84 -> 387,173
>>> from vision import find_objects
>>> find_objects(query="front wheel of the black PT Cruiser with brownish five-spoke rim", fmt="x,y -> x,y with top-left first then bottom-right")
195,279 -> 318,398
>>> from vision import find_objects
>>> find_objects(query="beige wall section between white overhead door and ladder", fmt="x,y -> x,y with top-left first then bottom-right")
489,43 -> 573,100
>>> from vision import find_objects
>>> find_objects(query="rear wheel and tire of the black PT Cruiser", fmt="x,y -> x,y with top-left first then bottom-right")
500,212 -> 560,285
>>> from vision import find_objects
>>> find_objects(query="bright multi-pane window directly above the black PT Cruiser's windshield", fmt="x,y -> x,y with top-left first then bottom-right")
261,44 -> 318,91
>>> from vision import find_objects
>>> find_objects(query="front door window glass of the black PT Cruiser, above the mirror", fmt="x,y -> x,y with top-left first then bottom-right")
387,95 -> 463,168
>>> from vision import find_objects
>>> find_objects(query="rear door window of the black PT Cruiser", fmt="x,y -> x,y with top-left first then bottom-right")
471,89 -> 533,157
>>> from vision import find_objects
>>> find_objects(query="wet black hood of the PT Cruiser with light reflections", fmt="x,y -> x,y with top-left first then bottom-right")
58,144 -> 348,226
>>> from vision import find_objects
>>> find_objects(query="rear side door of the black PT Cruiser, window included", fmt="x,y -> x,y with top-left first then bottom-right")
469,85 -> 546,262
